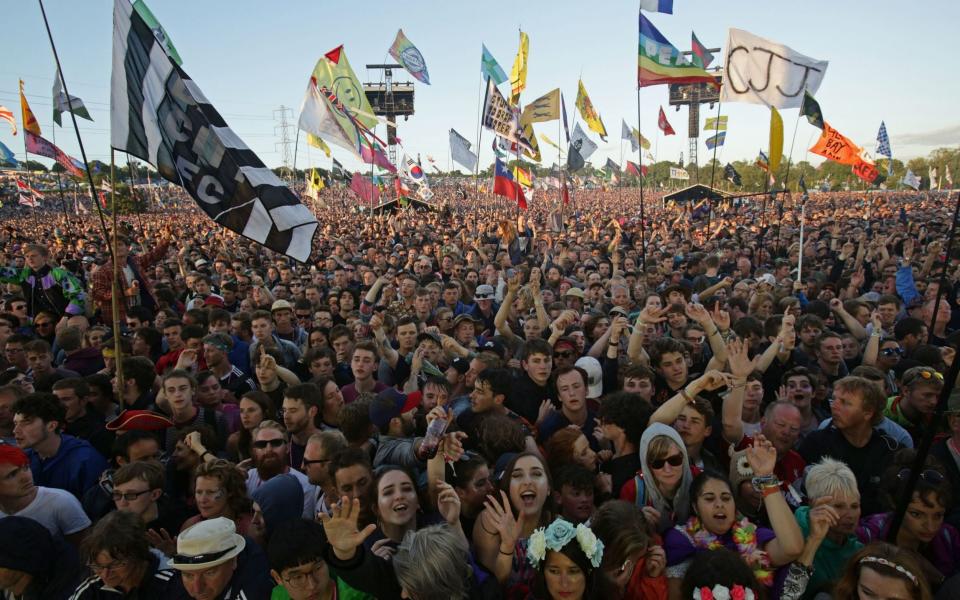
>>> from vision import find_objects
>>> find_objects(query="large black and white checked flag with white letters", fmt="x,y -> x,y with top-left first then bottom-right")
110,0 -> 318,262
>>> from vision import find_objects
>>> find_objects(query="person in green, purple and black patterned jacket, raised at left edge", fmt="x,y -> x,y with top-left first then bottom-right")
0,244 -> 87,322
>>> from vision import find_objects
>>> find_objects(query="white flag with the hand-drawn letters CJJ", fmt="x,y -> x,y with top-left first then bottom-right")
720,28 -> 827,108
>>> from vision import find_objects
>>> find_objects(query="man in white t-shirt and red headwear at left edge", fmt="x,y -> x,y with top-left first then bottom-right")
0,444 -> 90,545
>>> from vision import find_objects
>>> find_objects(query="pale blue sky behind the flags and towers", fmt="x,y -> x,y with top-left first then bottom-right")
0,0 -> 960,176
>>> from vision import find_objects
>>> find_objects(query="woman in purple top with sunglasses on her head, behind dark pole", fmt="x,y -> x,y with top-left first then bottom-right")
857,448 -> 960,590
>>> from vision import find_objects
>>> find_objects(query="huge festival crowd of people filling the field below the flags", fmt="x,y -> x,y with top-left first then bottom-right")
0,187 -> 960,600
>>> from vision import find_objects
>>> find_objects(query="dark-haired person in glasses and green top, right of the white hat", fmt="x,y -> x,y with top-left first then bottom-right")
267,519 -> 373,600
